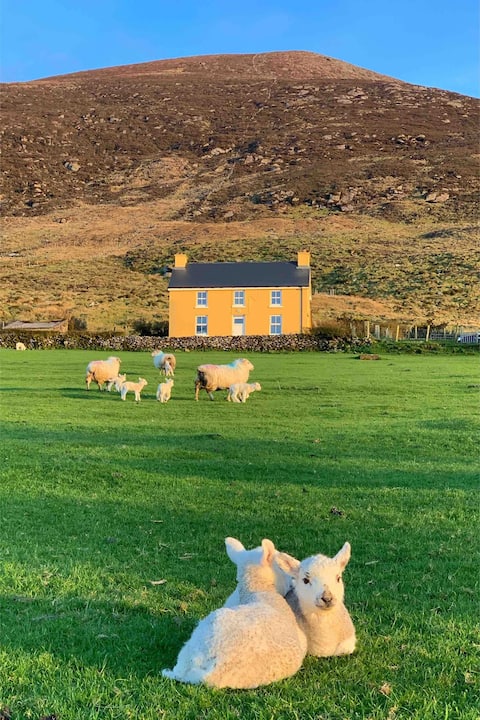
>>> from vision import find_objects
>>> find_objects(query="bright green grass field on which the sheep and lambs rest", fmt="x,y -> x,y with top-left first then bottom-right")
0,350 -> 480,720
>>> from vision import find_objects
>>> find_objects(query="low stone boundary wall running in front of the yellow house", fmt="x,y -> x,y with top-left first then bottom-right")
0,332 -> 369,353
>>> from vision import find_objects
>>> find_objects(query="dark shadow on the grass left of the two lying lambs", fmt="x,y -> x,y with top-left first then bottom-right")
0,595 -> 190,678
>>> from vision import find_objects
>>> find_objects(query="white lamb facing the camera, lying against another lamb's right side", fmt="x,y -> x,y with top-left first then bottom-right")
225,540 -> 356,657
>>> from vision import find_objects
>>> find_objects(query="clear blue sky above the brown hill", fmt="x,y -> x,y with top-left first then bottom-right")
0,0 -> 480,97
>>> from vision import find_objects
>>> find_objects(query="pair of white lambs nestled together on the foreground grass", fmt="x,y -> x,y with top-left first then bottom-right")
162,538 -> 356,689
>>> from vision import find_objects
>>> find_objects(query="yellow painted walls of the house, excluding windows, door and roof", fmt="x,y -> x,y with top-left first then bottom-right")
169,287 -> 312,337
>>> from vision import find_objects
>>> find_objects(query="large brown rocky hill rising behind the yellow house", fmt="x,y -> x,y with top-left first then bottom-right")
0,52 -> 480,329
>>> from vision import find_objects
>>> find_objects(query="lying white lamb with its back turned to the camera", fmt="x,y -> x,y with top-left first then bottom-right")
162,538 -> 307,688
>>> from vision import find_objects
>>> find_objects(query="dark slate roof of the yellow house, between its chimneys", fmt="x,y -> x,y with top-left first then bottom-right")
168,262 -> 310,290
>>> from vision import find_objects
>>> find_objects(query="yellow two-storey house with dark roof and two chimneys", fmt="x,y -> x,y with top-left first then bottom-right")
168,250 -> 312,337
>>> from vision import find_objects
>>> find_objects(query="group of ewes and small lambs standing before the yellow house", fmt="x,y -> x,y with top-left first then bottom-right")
85,350 -> 262,403
